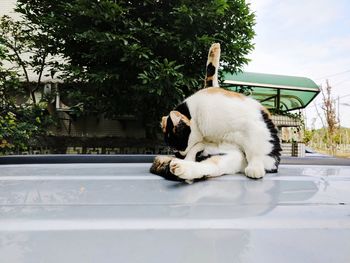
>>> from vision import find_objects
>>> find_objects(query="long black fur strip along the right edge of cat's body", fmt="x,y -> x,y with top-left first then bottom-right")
261,111 -> 282,173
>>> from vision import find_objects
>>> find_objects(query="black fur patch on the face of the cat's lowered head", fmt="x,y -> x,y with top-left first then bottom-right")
164,117 -> 191,151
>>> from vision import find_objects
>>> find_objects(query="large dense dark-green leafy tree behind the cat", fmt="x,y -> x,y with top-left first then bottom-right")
16,0 -> 255,139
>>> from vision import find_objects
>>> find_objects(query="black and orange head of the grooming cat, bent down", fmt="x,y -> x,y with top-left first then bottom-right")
161,111 -> 191,151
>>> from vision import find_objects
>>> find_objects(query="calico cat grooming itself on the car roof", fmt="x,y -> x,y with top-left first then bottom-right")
152,43 -> 281,180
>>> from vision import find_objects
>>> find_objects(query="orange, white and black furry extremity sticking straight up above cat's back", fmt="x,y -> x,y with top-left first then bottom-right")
204,43 -> 221,88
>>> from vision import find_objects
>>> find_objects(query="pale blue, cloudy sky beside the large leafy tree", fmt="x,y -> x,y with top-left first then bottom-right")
0,0 -> 350,128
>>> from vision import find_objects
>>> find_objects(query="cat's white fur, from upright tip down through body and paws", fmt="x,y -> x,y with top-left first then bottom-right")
165,43 -> 277,180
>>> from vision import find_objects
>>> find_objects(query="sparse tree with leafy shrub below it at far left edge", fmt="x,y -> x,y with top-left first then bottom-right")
0,23 -> 53,154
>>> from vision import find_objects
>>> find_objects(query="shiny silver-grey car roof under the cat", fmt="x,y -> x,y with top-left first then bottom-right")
0,157 -> 350,262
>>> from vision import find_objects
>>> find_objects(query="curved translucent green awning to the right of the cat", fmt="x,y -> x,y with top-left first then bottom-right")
222,72 -> 320,113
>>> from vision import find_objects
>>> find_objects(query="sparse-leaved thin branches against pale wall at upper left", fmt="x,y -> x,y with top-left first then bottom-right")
0,16 -> 57,105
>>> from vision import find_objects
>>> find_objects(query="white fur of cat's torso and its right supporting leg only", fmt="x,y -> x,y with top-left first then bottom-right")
171,88 -> 277,178
